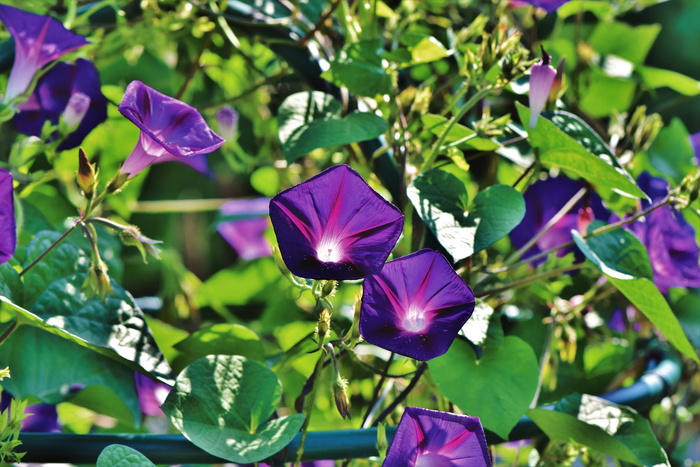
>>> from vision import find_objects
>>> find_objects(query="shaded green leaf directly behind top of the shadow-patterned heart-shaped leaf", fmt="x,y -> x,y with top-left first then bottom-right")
175,323 -> 265,368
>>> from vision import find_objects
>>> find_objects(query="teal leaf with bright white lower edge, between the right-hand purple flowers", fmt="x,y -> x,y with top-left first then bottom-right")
571,221 -> 653,279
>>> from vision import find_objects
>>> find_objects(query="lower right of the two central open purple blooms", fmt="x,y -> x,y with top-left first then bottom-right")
360,249 -> 474,361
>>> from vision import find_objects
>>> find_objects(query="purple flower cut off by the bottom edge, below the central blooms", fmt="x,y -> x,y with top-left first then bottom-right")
382,407 -> 492,467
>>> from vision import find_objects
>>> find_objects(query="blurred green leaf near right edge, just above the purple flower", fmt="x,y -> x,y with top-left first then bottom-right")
647,118 -> 697,182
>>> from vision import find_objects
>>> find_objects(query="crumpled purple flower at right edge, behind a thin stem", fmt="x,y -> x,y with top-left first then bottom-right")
628,172 -> 700,293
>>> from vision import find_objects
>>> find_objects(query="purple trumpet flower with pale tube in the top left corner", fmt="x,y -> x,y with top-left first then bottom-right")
0,5 -> 88,103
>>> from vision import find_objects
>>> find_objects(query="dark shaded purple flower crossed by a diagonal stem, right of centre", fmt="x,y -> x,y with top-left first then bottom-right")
510,177 -> 608,265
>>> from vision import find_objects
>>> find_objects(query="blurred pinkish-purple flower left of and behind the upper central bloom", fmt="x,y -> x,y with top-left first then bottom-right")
216,198 -> 272,259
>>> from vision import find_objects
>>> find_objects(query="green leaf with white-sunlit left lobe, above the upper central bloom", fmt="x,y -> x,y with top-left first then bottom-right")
278,91 -> 388,162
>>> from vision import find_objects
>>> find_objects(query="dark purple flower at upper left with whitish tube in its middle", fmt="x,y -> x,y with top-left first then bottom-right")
14,58 -> 107,151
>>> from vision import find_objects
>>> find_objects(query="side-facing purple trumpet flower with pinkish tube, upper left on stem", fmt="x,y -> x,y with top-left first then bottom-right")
119,81 -> 224,178
